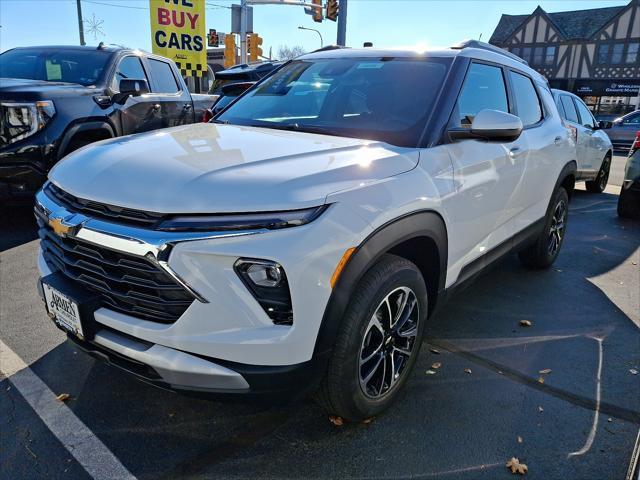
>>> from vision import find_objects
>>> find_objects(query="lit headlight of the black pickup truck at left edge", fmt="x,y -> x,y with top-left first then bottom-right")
0,100 -> 56,144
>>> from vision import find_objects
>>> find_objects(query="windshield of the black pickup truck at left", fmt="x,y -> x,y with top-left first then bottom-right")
0,48 -> 111,86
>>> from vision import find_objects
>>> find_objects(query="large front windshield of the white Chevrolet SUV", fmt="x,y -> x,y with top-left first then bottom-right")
216,58 -> 450,147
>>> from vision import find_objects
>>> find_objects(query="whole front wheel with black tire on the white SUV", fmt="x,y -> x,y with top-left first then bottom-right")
316,255 -> 428,422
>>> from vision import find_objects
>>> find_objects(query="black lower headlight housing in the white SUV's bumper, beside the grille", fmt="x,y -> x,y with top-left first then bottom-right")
233,258 -> 293,325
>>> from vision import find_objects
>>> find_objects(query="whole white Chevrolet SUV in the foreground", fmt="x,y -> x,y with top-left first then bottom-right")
36,42 -> 576,420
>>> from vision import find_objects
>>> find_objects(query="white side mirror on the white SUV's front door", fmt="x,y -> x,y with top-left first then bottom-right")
449,109 -> 523,143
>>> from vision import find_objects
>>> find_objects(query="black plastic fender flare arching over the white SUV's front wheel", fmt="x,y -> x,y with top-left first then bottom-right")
314,210 -> 448,360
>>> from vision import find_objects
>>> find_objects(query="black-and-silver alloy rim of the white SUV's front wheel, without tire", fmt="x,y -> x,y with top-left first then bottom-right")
358,287 -> 420,399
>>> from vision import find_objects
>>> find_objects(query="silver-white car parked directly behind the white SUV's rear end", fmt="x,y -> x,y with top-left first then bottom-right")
551,89 -> 613,193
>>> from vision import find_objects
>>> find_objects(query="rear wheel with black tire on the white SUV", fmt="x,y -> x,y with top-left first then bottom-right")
518,187 -> 569,270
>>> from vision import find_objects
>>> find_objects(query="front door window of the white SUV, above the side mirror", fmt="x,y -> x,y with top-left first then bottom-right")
454,63 -> 509,127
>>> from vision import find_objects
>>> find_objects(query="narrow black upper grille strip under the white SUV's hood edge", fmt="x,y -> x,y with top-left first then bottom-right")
45,183 -> 165,228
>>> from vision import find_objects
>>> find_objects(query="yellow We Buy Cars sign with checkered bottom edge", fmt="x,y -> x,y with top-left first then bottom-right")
149,0 -> 207,77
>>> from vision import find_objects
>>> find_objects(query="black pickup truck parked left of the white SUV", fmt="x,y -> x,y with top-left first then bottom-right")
0,44 -> 216,202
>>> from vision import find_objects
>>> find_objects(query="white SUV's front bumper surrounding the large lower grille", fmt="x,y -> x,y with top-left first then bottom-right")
37,187 -> 369,393
